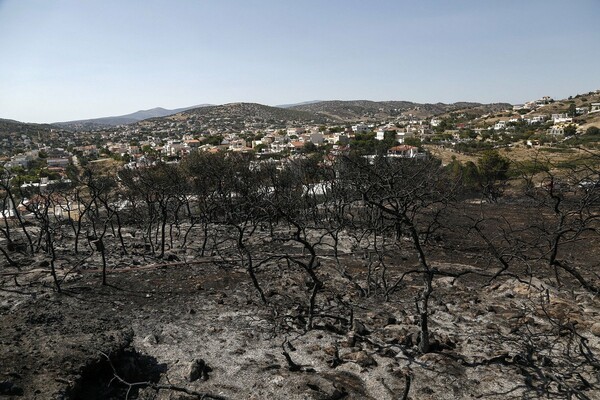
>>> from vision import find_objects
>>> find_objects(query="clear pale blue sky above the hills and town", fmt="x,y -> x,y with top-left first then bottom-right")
0,0 -> 600,122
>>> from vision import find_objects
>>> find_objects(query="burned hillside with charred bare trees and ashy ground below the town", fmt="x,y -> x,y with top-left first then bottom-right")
0,153 -> 600,399
